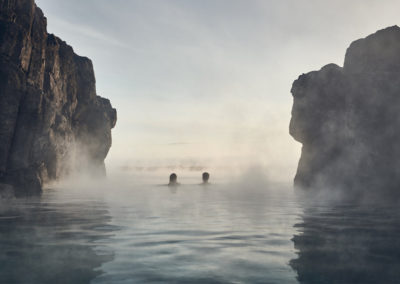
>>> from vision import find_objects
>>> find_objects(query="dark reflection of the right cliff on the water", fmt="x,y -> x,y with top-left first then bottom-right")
290,206 -> 400,284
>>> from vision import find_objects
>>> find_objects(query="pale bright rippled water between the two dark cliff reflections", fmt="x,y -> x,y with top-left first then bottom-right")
93,185 -> 298,284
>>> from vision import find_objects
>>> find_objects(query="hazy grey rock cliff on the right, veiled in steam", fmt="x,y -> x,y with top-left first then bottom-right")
290,26 -> 400,194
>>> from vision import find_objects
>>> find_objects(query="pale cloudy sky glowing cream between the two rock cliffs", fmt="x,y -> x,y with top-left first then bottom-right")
36,0 -> 400,179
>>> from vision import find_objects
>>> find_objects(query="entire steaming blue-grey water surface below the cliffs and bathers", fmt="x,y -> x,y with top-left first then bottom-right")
0,181 -> 400,283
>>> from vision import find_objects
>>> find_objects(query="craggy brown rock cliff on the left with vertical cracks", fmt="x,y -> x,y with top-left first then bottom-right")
0,0 -> 116,195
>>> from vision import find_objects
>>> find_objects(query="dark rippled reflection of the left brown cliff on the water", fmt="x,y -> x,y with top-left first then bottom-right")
0,192 -> 116,283
